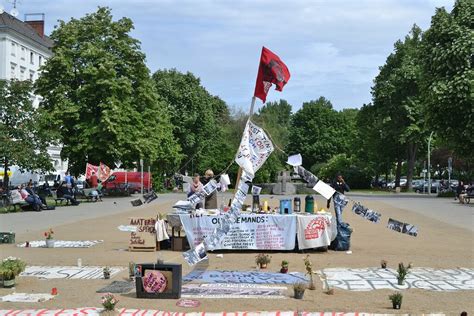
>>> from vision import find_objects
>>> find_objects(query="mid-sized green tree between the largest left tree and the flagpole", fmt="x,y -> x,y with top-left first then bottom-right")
153,69 -> 232,174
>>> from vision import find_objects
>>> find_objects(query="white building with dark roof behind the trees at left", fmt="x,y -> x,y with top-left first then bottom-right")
0,12 -> 67,172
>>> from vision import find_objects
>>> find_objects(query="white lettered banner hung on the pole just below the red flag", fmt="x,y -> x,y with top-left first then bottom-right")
235,120 -> 274,177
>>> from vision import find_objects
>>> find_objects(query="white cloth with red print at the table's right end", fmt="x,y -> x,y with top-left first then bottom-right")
297,214 -> 337,249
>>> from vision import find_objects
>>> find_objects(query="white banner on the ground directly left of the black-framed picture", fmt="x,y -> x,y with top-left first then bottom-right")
20,266 -> 125,280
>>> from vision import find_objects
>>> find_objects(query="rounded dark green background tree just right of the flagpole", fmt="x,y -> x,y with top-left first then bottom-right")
287,97 -> 350,170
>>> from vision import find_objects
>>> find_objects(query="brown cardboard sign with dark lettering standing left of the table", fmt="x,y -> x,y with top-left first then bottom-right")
129,217 -> 156,250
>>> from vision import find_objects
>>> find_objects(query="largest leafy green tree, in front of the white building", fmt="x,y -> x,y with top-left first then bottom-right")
36,7 -> 180,174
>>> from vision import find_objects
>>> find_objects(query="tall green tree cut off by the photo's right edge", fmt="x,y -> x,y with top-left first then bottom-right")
421,0 -> 474,160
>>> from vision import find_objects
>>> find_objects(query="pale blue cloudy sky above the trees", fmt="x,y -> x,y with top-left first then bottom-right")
0,0 -> 454,111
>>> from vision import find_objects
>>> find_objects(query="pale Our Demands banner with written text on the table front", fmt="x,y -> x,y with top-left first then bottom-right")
179,214 -> 296,250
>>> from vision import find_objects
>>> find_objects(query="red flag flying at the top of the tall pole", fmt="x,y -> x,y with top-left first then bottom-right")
254,47 -> 290,103
